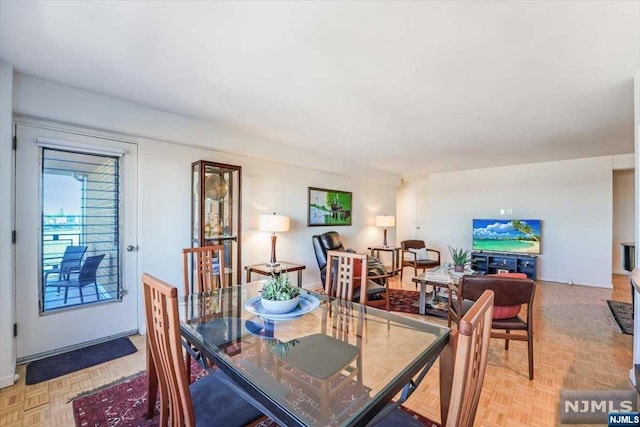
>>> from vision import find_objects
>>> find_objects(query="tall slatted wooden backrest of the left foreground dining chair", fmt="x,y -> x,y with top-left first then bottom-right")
142,274 -> 195,427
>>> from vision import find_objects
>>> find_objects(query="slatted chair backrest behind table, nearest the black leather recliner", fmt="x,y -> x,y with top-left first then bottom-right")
324,251 -> 367,304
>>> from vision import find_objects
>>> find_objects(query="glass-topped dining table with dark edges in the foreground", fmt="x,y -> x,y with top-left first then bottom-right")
179,281 -> 449,426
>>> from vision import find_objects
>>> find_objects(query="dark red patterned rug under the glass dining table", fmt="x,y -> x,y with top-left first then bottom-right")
72,368 -> 440,427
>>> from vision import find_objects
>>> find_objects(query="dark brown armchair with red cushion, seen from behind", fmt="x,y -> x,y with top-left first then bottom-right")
449,274 -> 536,380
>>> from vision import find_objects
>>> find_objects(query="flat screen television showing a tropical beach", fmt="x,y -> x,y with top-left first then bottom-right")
473,219 -> 541,254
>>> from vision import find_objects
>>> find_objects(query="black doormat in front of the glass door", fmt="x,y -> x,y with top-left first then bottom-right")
26,337 -> 138,385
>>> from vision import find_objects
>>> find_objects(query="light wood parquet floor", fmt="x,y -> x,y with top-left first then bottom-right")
0,276 -> 632,427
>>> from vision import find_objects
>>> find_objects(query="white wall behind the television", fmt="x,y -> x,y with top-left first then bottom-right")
413,156 -> 613,287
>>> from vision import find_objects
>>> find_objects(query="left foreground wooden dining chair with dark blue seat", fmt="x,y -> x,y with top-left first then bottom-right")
142,274 -> 263,427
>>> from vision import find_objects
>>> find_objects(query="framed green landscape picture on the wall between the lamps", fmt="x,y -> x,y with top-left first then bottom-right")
307,187 -> 352,227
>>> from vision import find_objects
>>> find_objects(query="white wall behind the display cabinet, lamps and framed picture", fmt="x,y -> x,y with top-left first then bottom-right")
139,141 -> 396,287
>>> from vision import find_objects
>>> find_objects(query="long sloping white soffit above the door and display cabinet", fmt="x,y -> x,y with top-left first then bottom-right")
13,74 -> 400,185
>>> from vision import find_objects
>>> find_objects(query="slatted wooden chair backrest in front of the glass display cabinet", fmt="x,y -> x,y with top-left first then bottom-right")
182,245 -> 226,295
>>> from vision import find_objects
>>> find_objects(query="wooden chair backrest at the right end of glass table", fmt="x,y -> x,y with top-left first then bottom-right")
440,290 -> 494,427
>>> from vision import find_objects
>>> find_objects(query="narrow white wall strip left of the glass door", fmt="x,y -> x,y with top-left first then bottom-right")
0,61 -> 16,388
